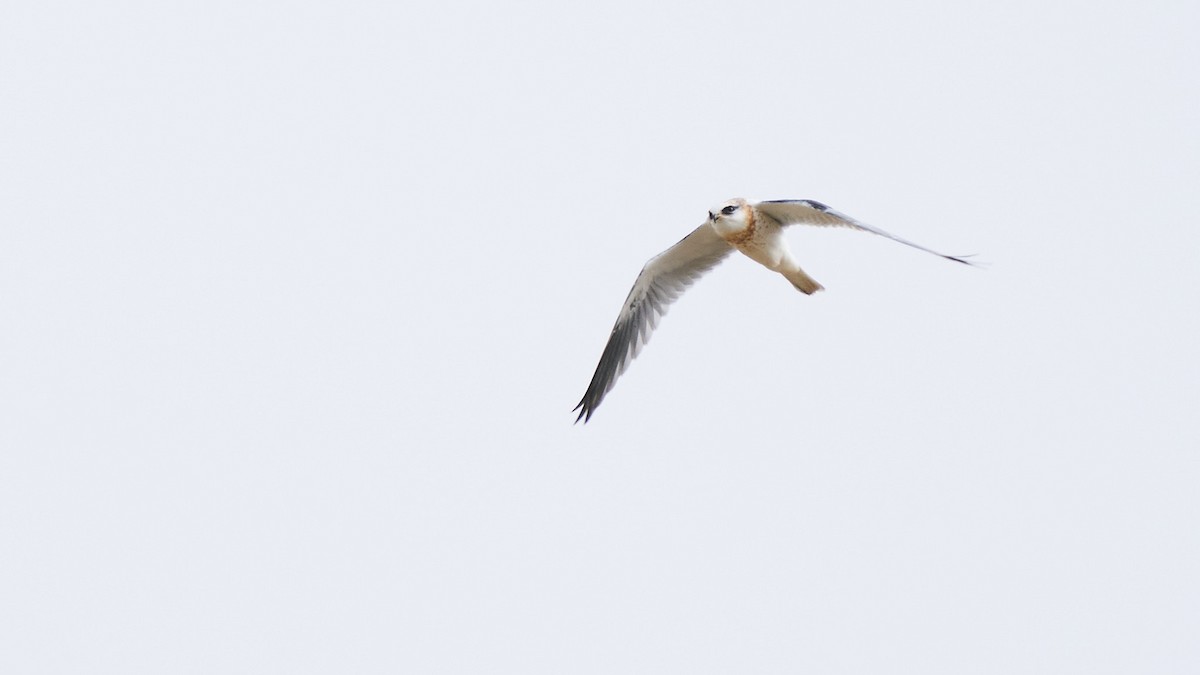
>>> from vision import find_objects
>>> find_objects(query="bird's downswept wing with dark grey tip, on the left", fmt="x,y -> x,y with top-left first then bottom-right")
575,223 -> 733,423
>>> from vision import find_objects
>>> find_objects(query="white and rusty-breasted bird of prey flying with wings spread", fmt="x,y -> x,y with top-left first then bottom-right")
572,199 -> 974,424
